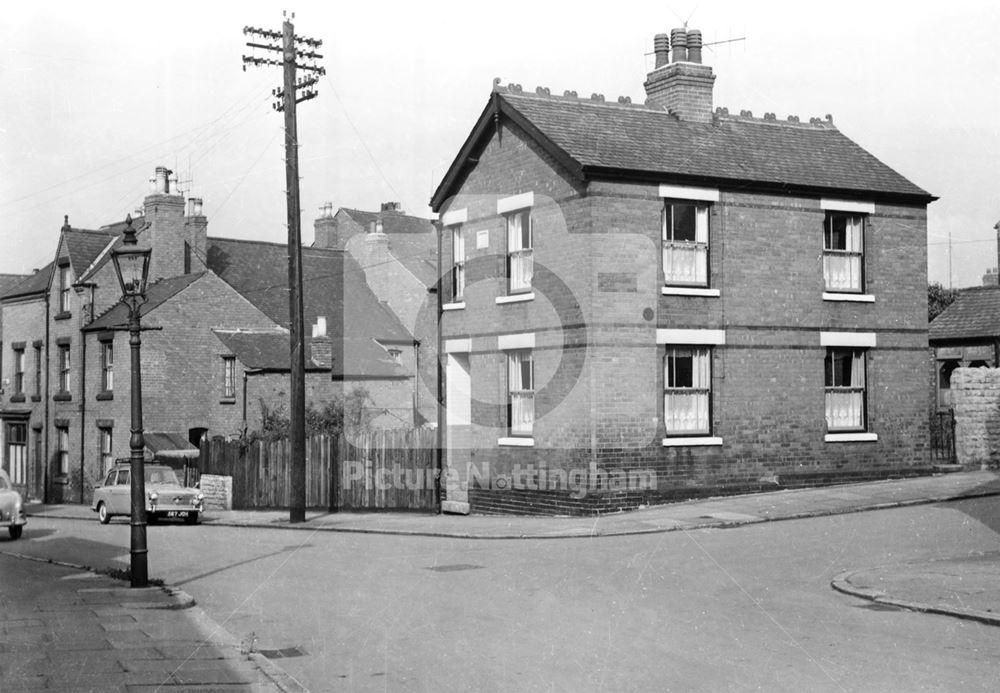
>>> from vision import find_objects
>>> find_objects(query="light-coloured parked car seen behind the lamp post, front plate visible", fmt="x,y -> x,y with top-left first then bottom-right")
91,464 -> 205,525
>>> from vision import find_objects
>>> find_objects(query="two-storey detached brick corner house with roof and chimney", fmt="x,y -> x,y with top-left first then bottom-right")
431,29 -> 935,513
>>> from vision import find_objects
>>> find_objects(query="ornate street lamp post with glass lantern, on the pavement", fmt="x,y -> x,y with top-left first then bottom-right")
111,215 -> 152,587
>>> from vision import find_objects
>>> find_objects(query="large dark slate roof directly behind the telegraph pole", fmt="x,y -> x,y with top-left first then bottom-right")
207,238 -> 413,341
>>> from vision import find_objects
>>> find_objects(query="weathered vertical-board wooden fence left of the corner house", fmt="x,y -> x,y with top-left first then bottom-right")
198,429 -> 436,510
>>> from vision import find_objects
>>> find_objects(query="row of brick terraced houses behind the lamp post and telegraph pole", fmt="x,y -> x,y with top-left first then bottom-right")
0,167 -> 414,503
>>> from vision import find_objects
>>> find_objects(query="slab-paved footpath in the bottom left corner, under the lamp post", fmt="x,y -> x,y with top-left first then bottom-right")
0,542 -> 305,693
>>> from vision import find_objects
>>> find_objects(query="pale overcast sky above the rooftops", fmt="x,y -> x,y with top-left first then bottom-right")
0,0 -> 1000,286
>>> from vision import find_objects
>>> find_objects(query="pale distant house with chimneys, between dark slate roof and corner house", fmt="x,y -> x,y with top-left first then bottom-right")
313,202 -> 438,424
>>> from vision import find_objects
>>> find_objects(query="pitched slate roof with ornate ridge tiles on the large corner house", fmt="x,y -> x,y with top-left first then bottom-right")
431,87 -> 934,211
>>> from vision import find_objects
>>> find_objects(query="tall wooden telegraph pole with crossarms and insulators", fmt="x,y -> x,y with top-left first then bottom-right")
243,14 -> 326,522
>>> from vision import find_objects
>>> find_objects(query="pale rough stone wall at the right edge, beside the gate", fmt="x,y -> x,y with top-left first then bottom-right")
951,368 -> 1000,469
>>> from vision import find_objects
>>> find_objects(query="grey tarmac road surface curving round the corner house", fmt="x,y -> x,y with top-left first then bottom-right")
9,498 -> 1000,691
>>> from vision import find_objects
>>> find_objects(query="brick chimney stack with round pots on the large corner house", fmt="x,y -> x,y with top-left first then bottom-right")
643,29 -> 715,123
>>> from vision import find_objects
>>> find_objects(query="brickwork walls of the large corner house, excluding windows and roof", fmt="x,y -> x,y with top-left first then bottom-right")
441,117 -> 930,512
